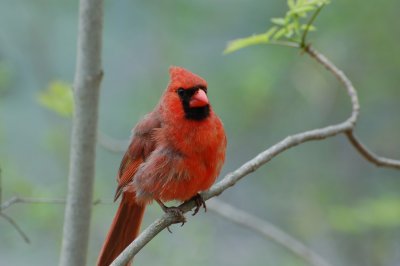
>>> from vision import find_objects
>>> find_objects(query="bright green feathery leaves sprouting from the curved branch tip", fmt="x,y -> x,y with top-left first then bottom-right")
224,0 -> 329,54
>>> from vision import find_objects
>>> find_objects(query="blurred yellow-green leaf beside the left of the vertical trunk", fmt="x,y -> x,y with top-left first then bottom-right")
37,80 -> 74,117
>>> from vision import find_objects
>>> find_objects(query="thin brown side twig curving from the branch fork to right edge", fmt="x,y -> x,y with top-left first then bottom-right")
346,130 -> 400,169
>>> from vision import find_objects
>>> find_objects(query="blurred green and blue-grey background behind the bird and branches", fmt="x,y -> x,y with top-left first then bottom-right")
0,0 -> 400,266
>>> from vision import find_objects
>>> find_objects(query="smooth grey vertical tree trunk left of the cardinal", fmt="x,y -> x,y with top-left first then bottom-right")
59,0 -> 103,266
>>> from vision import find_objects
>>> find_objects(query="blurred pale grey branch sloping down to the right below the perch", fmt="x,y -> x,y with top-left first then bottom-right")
207,198 -> 331,266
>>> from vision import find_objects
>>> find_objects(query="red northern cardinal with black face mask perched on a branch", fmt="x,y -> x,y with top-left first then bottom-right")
97,67 -> 226,266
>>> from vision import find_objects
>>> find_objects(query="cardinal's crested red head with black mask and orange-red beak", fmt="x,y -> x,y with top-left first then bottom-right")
166,66 -> 210,120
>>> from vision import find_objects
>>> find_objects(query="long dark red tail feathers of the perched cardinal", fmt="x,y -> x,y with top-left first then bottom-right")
97,192 -> 146,266
